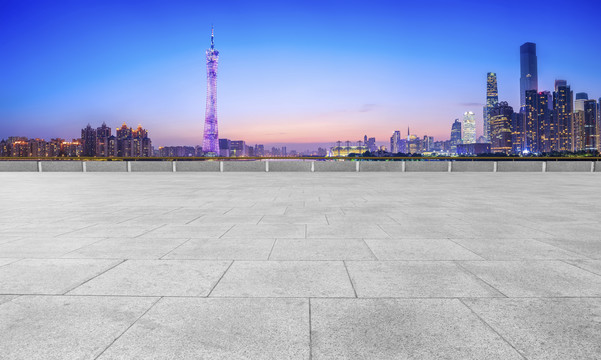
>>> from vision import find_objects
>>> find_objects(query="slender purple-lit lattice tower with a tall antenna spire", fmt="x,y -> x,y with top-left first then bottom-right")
202,28 -> 219,156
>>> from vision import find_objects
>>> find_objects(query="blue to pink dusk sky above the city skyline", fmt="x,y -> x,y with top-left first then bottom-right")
0,0 -> 601,150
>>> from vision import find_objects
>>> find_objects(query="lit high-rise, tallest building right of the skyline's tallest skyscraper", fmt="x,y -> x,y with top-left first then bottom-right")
553,80 -> 574,151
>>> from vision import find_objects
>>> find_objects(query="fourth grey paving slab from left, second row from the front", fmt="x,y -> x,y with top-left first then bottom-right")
346,261 -> 502,298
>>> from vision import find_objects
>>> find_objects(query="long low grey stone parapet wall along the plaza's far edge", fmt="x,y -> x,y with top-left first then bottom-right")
0,157 -> 601,172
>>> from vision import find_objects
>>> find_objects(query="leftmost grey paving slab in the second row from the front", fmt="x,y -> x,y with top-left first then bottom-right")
0,259 -> 119,294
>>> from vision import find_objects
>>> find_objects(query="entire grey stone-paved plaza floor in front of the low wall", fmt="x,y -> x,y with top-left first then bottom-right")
0,173 -> 601,359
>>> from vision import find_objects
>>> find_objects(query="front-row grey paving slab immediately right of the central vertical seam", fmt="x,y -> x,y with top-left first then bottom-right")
311,299 -> 522,360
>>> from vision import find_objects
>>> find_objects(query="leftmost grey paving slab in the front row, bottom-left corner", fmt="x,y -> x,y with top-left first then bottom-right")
0,296 -> 156,360
